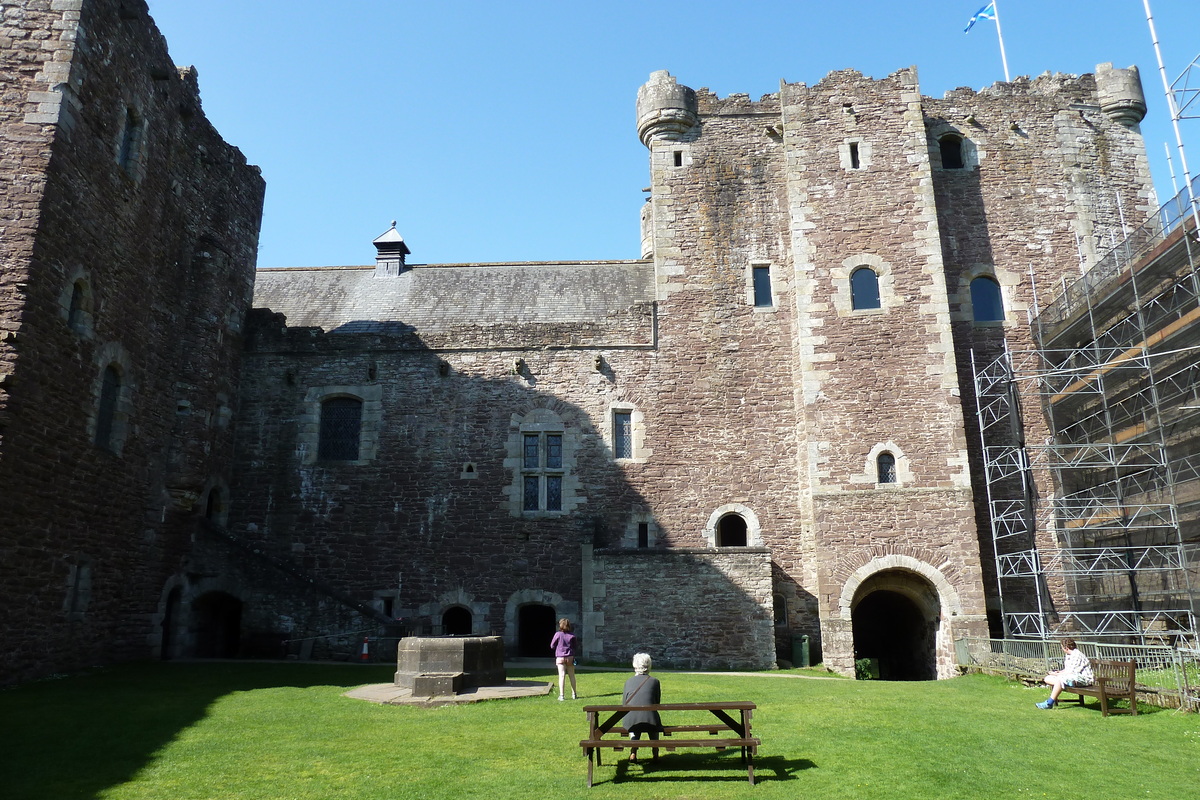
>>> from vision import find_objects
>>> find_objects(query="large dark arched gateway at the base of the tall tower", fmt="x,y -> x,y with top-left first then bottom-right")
851,570 -> 941,680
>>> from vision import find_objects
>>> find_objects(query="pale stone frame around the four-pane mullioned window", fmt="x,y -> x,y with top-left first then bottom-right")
503,408 -> 583,519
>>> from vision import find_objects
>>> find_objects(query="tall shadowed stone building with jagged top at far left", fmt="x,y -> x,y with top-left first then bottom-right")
0,0 -> 263,680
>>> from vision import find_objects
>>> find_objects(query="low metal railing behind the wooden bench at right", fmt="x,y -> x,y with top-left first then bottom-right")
954,637 -> 1200,711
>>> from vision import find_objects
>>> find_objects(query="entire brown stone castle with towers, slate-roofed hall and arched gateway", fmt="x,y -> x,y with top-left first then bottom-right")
0,0 -> 1157,681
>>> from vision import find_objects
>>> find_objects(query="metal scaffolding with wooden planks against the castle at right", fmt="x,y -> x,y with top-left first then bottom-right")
972,179 -> 1200,644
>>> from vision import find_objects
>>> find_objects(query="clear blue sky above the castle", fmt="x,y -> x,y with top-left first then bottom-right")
149,0 -> 1200,266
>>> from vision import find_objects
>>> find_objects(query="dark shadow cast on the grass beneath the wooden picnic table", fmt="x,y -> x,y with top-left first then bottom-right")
593,751 -> 817,784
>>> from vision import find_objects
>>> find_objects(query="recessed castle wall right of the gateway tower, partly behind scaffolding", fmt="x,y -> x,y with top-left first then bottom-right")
923,65 -> 1157,633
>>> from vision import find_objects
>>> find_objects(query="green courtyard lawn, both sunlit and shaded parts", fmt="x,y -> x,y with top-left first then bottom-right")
0,663 -> 1200,800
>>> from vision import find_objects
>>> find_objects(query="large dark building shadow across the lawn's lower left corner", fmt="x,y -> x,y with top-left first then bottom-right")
0,662 -> 395,800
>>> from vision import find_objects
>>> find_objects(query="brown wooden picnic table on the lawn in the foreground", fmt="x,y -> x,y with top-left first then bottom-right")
580,700 -> 762,787
